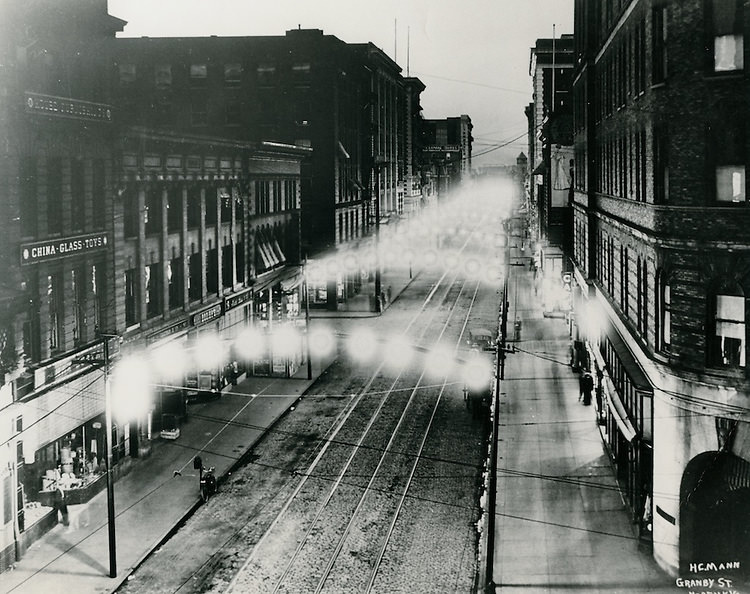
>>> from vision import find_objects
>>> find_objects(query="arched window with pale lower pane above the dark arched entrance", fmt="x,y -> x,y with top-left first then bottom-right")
708,283 -> 746,368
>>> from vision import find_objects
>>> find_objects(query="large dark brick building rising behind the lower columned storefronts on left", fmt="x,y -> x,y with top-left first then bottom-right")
116,29 -> 424,308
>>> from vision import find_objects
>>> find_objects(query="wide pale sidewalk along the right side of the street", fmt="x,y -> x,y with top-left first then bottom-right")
493,269 -> 678,594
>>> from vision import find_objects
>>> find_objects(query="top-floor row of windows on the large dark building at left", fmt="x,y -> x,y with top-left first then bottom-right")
118,62 -> 310,90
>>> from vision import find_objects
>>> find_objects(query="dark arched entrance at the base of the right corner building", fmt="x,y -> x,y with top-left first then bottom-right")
680,452 -> 750,578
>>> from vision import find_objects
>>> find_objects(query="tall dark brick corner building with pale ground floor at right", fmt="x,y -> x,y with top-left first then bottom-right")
572,0 -> 750,577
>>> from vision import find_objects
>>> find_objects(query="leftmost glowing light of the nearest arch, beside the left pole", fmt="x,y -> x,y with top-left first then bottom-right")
109,355 -> 153,423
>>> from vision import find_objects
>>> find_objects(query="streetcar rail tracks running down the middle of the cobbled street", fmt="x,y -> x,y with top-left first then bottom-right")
228,262 -> 490,592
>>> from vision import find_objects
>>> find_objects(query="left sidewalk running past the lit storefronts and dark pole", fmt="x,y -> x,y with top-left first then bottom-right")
0,274 -> 416,594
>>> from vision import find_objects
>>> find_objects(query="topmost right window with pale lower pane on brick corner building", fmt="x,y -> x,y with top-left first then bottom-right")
710,0 -> 745,72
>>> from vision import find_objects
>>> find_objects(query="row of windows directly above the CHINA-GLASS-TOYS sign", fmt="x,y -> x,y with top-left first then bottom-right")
18,156 -> 106,237
